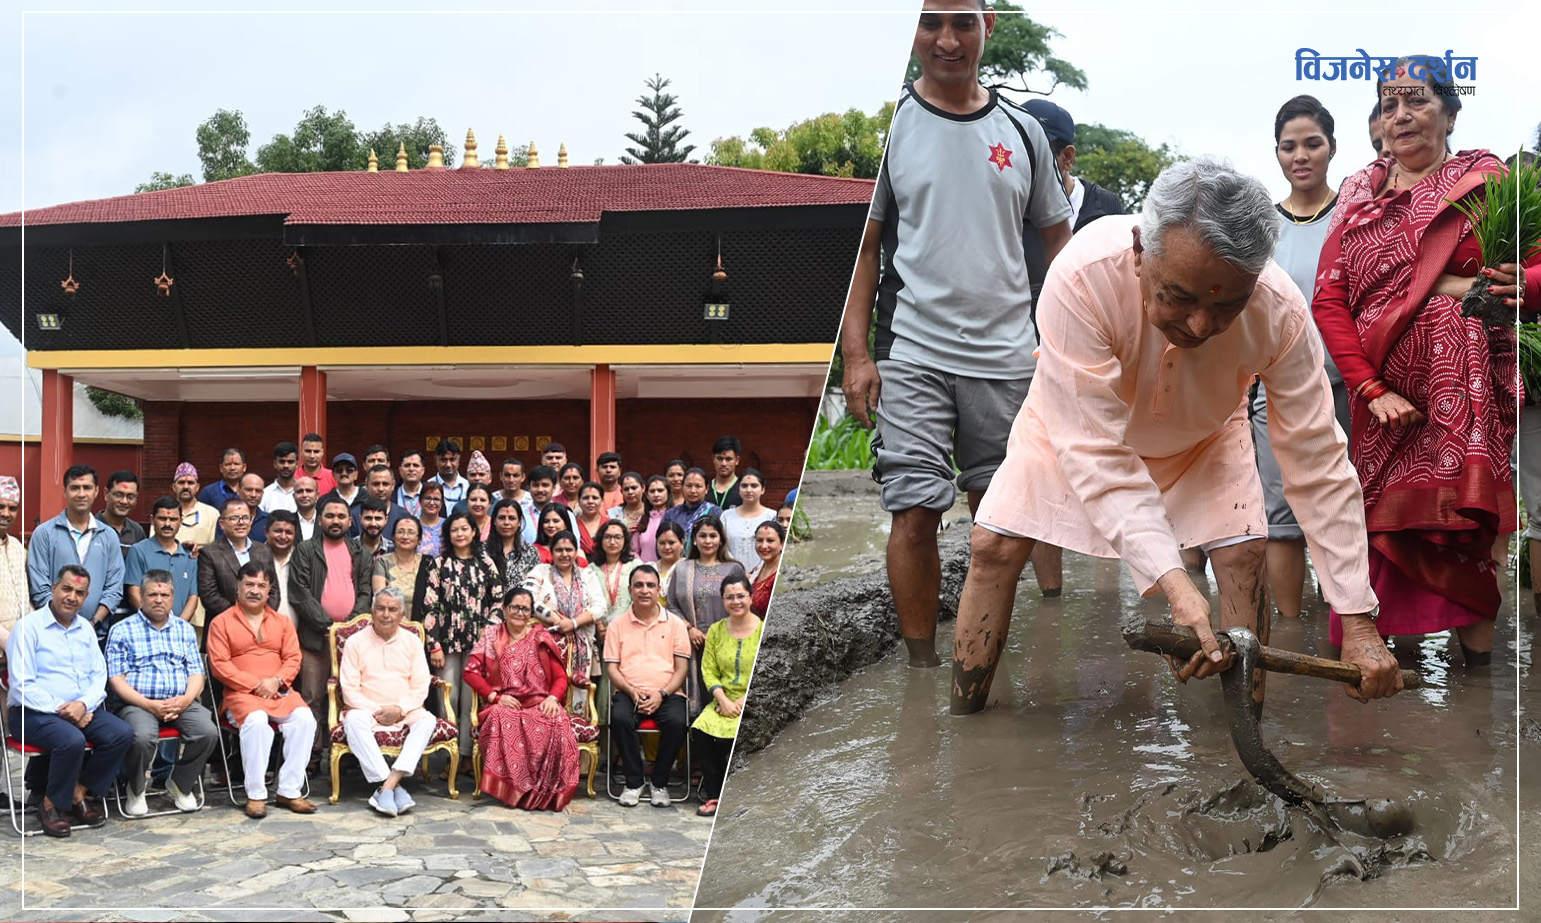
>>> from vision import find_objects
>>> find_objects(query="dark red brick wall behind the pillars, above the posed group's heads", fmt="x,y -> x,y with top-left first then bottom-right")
140,398 -> 818,504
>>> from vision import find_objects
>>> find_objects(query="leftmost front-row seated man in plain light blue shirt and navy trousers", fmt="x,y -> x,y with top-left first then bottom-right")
6,563 -> 134,837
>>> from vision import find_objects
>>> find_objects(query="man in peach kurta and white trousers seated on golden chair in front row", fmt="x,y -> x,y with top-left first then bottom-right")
337,587 -> 438,817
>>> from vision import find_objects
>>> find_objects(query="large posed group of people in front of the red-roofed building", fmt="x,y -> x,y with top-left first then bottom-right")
0,435 -> 791,837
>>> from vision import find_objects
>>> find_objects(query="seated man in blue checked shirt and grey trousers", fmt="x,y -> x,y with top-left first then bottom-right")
106,570 -> 219,817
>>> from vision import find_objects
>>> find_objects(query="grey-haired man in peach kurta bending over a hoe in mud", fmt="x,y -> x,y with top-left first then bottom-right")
952,162 -> 1401,713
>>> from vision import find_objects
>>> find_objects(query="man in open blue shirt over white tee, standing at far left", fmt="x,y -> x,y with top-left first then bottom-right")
26,465 -> 123,635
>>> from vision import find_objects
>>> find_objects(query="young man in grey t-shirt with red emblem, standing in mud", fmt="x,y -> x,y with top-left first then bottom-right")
840,0 -> 1071,666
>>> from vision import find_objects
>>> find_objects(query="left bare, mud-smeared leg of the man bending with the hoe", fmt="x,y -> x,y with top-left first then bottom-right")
952,525 -> 1037,715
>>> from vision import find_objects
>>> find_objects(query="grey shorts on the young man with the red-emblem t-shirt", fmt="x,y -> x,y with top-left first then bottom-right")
872,359 -> 1032,513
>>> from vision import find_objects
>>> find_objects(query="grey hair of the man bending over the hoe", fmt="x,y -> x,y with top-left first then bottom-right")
1140,157 -> 1279,274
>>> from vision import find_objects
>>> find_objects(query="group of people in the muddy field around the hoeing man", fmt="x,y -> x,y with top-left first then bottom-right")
841,0 -> 1541,712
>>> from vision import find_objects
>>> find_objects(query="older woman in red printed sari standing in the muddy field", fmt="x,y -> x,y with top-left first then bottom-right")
1311,60 -> 1541,666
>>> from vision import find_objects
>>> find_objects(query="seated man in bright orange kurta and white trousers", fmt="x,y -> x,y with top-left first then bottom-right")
208,561 -> 316,818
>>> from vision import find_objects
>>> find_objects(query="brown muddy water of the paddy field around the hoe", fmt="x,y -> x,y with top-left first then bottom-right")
697,482 -> 1541,920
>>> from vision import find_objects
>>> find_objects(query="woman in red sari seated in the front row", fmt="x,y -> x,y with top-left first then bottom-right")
465,587 -> 578,811
